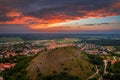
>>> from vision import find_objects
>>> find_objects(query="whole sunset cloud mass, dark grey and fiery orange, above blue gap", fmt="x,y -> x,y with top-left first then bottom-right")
0,0 -> 120,29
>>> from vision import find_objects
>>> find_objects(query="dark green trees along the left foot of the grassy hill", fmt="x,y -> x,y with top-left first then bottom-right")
2,55 -> 37,80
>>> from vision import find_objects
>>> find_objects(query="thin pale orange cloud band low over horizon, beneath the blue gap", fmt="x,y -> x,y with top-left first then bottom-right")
28,25 -> 111,32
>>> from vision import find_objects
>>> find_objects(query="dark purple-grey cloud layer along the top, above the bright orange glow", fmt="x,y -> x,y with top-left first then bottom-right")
0,0 -> 120,22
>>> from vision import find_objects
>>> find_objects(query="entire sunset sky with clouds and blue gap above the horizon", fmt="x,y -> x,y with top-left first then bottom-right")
0,0 -> 120,33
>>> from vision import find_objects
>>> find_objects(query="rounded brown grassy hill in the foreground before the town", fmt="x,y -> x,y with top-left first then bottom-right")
27,47 -> 95,80
